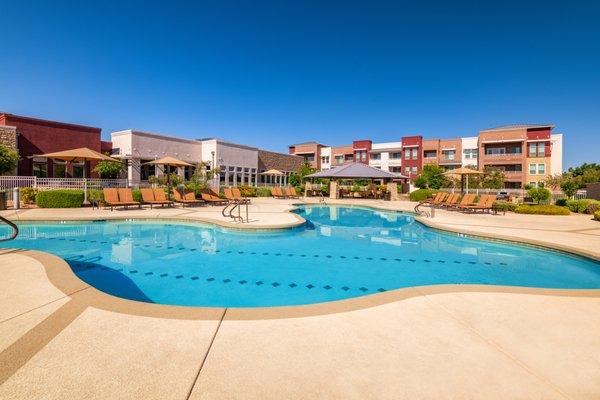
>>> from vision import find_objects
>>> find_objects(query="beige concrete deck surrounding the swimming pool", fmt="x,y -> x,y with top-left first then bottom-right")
0,199 -> 600,399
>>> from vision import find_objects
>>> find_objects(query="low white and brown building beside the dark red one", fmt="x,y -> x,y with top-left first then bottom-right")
111,129 -> 304,186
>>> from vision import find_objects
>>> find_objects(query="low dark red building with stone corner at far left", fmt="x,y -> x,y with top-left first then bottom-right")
0,113 -> 112,178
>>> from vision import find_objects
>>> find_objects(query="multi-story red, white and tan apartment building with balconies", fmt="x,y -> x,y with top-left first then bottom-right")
289,124 -> 562,188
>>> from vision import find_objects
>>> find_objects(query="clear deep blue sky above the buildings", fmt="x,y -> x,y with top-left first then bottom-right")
0,0 -> 600,167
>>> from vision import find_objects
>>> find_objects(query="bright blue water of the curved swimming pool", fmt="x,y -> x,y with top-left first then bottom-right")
0,206 -> 600,307
